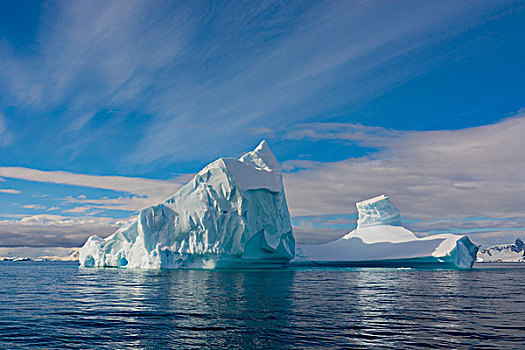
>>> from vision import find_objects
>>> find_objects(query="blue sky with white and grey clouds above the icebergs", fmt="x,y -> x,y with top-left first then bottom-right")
0,0 -> 525,251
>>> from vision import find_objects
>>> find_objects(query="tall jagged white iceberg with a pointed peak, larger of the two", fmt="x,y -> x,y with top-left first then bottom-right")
79,141 -> 295,268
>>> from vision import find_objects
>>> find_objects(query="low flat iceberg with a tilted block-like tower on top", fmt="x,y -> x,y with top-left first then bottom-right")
292,195 -> 478,268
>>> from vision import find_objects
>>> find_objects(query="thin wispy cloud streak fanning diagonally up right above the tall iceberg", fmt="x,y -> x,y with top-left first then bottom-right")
128,2 -> 486,164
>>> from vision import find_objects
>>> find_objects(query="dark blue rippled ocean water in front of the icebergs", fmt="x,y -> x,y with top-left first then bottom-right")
0,262 -> 525,349
